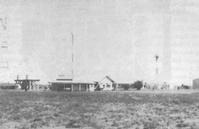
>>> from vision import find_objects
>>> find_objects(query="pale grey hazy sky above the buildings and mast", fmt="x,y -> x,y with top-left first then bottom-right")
0,0 -> 199,85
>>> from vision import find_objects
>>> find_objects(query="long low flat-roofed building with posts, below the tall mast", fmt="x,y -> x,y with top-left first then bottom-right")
49,81 -> 94,91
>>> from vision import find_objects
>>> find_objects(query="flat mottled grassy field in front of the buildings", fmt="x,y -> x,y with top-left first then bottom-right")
0,91 -> 199,129
